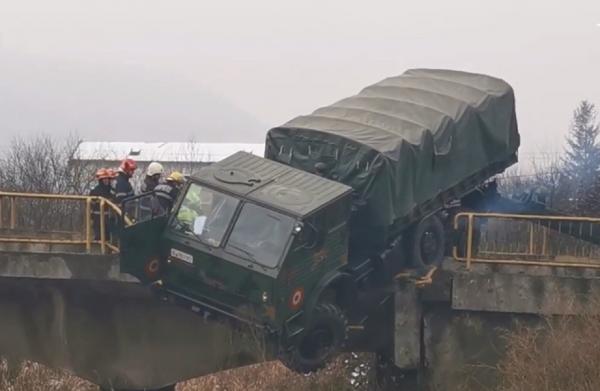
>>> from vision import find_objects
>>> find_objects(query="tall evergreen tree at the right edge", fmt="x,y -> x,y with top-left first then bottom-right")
563,100 -> 600,211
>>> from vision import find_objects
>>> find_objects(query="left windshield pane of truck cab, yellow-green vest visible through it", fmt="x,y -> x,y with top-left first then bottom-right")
173,183 -> 239,247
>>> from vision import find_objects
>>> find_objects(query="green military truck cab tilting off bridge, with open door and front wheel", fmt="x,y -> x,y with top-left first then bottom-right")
121,152 -> 352,372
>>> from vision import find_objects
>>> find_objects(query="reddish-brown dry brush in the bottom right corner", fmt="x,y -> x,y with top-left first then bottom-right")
498,315 -> 600,391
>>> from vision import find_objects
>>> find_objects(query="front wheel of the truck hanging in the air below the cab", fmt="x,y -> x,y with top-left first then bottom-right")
279,303 -> 348,373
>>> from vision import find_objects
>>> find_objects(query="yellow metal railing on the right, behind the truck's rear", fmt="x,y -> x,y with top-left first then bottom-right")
453,212 -> 600,269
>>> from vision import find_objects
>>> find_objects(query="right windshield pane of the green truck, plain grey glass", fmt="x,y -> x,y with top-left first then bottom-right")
225,204 -> 295,267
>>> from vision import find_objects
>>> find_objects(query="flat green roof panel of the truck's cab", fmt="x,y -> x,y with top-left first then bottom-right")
192,152 -> 352,217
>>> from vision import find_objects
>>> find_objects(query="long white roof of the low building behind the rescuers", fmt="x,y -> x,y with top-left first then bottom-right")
73,141 -> 265,163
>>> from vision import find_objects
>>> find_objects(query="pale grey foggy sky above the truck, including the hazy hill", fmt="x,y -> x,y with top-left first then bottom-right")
0,0 -> 600,159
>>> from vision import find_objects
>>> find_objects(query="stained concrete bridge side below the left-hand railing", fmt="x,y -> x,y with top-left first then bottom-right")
0,251 -> 264,390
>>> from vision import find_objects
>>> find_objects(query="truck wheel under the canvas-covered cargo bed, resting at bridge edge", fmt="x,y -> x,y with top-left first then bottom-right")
406,215 -> 446,269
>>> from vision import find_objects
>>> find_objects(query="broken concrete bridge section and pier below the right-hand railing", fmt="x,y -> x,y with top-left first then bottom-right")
378,260 -> 600,391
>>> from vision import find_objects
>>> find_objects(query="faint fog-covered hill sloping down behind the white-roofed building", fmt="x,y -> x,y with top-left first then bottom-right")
0,49 -> 267,142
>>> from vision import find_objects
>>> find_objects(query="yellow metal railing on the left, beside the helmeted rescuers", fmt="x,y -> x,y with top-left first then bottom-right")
0,192 -> 127,254
